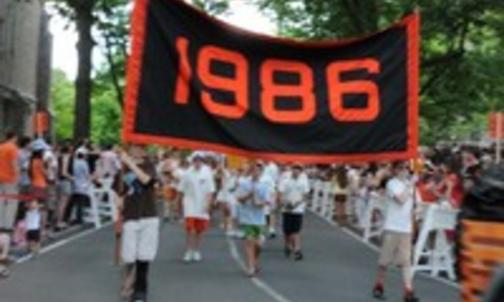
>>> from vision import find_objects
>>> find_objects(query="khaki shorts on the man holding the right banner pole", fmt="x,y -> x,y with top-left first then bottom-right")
379,231 -> 412,267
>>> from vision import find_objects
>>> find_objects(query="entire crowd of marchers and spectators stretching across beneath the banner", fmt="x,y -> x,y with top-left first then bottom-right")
0,133 -> 498,302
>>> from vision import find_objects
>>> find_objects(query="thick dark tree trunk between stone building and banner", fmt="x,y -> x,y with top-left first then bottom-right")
73,0 -> 95,141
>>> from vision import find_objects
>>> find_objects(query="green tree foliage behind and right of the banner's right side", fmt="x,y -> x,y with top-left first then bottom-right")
255,0 -> 504,144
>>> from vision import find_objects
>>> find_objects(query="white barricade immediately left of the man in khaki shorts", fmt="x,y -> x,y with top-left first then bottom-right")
363,192 -> 385,242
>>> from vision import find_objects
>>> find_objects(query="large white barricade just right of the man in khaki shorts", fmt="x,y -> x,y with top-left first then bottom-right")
413,205 -> 458,280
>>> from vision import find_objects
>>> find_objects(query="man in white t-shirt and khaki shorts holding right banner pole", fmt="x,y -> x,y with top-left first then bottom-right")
373,162 -> 419,302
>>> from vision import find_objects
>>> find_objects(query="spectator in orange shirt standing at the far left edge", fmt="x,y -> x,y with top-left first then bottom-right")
0,132 -> 19,232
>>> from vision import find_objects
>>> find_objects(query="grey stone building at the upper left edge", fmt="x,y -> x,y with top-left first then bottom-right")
0,0 -> 52,137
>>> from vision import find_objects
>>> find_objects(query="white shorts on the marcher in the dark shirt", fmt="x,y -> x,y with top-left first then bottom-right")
121,217 -> 159,264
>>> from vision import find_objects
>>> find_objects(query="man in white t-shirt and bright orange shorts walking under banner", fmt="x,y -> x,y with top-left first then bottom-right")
179,155 -> 215,262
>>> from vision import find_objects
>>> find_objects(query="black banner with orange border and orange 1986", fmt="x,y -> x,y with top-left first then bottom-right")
123,0 -> 419,163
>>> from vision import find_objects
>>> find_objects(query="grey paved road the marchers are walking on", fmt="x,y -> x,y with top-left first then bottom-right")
0,216 -> 459,302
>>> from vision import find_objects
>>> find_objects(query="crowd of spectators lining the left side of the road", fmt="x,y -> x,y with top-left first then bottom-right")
0,132 -> 121,277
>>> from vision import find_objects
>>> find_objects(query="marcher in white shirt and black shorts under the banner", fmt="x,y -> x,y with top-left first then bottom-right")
279,165 -> 310,261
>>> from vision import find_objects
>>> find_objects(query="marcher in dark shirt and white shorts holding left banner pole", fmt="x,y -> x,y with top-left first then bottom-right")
114,146 -> 160,302
